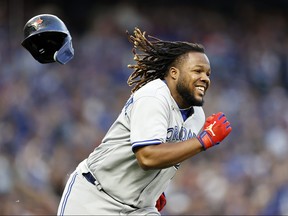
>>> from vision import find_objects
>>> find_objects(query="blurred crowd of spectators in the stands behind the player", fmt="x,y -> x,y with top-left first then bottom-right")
0,1 -> 288,215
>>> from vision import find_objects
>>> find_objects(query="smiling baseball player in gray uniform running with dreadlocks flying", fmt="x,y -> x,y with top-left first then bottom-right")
58,28 -> 232,215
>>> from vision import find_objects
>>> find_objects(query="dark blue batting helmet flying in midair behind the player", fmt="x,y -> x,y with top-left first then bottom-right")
21,14 -> 74,64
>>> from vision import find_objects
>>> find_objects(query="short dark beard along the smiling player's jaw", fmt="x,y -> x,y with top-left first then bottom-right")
176,79 -> 204,107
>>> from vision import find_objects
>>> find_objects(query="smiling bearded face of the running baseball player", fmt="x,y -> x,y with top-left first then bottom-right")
176,52 -> 211,108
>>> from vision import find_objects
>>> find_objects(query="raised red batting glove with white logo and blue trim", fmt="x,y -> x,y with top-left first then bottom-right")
197,112 -> 232,150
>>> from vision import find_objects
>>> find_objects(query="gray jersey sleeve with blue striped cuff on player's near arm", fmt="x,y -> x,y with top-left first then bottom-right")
130,96 -> 169,151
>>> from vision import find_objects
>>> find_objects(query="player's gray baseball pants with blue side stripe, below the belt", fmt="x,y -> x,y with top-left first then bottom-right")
57,160 -> 160,216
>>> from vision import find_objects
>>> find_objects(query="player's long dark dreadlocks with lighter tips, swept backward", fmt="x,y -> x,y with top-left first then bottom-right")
126,27 -> 205,93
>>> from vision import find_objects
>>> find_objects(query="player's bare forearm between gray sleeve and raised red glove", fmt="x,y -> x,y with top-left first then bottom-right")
136,137 -> 203,170
